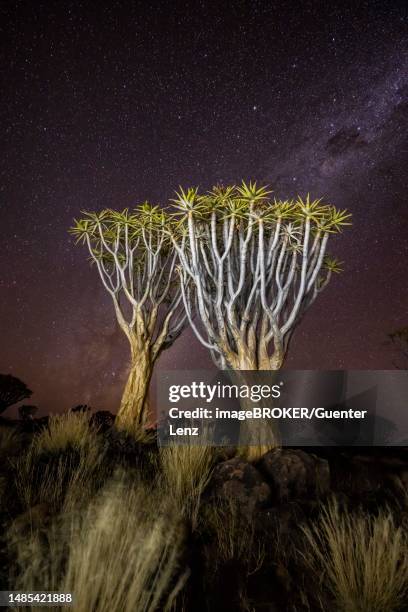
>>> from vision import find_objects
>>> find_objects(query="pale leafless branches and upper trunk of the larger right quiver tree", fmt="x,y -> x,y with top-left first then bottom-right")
174,212 -> 330,370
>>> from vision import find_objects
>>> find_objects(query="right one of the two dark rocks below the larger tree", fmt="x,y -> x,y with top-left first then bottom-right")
258,449 -> 330,503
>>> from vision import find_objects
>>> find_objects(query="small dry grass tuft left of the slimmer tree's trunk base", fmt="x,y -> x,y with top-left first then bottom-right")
34,412 -> 96,453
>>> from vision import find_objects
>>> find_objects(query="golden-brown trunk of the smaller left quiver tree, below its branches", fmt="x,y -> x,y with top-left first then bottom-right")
115,350 -> 154,431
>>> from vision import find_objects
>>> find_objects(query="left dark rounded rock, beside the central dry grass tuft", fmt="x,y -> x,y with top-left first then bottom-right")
212,457 -> 271,517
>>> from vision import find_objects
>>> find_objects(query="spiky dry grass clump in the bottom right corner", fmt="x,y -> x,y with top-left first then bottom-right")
303,501 -> 408,612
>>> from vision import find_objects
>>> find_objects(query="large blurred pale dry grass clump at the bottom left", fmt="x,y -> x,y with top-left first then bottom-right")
11,480 -> 187,612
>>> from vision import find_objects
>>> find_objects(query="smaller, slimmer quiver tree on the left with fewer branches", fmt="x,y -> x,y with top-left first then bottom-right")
71,203 -> 186,428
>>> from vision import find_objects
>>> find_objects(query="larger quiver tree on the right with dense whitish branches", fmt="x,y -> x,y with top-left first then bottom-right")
172,183 -> 350,454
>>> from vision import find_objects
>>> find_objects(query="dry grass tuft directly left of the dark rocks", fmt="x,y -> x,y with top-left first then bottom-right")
160,444 -> 216,529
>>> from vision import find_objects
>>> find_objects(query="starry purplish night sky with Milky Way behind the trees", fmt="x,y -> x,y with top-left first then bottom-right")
0,1 -> 408,414
